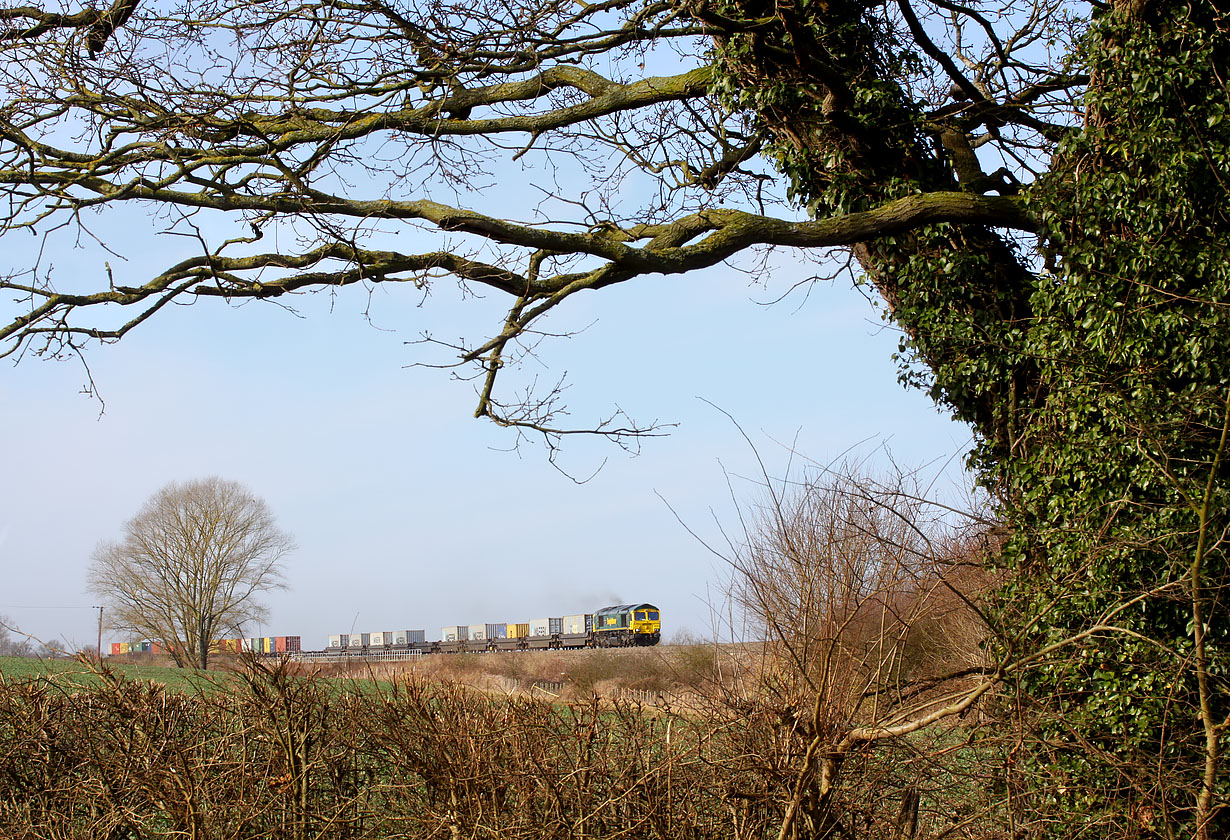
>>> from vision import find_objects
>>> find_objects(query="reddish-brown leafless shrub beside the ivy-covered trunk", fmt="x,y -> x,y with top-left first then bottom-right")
726,466 -> 1009,840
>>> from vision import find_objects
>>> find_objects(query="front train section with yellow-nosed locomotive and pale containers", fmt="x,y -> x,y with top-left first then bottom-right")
326,604 -> 662,656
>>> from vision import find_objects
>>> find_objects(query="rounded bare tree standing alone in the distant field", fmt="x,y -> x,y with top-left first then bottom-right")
90,477 -> 294,668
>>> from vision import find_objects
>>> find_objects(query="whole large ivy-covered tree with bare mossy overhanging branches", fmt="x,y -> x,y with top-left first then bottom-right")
0,0 -> 1230,838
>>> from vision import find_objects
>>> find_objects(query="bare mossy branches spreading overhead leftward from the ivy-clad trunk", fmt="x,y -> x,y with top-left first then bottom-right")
0,0 -> 1057,447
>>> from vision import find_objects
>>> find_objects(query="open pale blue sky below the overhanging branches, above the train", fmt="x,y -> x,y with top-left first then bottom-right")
0,233 -> 968,648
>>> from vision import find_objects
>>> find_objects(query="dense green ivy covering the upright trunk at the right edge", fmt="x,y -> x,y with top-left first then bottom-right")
1000,4 -> 1230,836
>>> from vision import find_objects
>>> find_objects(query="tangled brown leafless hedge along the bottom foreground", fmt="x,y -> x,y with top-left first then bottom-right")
0,663 -> 1003,840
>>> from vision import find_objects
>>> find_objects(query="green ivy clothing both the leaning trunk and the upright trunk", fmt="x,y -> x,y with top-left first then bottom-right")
720,0 -> 1230,836
